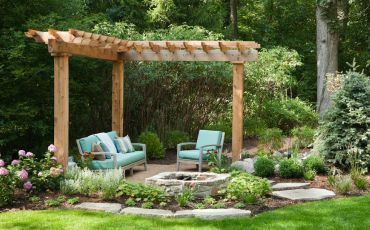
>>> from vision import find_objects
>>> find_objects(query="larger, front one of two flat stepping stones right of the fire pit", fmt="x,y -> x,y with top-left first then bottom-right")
272,188 -> 335,200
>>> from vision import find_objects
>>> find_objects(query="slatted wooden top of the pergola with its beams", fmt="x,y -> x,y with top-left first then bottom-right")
25,29 -> 260,62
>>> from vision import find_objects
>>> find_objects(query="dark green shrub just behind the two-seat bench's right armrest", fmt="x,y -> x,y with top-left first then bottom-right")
139,131 -> 165,159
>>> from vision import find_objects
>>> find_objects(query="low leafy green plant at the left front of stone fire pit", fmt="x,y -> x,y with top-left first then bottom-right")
116,182 -> 166,203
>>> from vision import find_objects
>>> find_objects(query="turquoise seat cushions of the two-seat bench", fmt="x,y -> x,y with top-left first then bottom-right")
91,151 -> 145,170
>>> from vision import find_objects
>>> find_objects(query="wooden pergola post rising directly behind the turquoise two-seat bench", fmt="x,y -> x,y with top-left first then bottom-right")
112,60 -> 124,136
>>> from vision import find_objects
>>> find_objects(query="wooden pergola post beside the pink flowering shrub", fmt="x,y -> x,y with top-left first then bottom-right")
52,53 -> 69,170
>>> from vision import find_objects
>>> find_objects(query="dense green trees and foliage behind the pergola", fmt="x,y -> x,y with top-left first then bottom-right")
0,0 -> 369,159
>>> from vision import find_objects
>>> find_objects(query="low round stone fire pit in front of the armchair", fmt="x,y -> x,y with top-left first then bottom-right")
145,172 -> 230,197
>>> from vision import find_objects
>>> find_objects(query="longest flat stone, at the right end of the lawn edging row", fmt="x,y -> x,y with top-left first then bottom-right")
174,208 -> 251,220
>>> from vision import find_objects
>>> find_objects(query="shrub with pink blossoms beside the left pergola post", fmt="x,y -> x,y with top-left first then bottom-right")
0,145 -> 63,207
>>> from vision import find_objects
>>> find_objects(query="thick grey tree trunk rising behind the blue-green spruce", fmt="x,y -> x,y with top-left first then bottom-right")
316,1 -> 339,116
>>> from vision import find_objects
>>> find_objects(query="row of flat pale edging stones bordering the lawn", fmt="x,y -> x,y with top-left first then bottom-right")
74,202 -> 251,220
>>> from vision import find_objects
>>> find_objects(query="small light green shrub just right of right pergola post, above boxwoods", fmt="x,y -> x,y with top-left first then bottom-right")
258,128 -> 283,152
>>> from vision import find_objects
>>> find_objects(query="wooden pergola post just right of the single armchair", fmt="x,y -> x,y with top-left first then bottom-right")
232,62 -> 244,161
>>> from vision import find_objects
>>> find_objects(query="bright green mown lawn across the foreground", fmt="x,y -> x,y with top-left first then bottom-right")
0,196 -> 370,230
